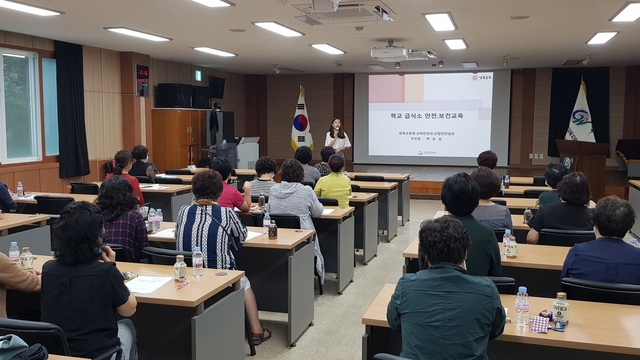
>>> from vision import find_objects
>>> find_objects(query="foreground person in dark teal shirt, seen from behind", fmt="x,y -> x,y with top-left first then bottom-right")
387,216 -> 505,360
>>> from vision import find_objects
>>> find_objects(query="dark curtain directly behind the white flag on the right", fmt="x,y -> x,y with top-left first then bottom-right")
547,67 -> 609,157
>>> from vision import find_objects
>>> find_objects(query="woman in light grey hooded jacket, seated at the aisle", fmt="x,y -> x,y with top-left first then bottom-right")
267,159 -> 324,284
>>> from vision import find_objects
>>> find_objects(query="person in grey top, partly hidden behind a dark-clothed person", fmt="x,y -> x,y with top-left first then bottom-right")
471,166 -> 513,230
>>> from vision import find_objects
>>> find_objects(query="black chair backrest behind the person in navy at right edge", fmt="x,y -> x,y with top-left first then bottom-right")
561,278 -> 640,305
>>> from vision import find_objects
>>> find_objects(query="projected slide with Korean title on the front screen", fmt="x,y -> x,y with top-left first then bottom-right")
368,72 -> 494,158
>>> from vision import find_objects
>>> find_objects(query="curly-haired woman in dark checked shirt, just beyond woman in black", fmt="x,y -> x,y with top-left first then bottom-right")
96,176 -> 149,262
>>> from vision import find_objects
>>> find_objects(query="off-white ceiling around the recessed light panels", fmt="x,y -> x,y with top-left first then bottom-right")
0,0 -> 640,74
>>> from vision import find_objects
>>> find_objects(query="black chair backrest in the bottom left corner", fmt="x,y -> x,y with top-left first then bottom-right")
0,318 -> 70,355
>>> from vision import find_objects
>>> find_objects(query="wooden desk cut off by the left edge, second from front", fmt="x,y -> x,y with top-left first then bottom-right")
0,213 -> 51,254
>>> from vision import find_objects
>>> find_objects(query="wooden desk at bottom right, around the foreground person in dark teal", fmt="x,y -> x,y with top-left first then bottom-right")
362,284 -> 640,360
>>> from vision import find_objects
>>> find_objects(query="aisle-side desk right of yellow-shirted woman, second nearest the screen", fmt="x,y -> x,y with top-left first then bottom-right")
351,181 -> 398,241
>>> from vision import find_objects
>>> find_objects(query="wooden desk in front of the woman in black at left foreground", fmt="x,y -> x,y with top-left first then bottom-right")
29,255 -> 245,360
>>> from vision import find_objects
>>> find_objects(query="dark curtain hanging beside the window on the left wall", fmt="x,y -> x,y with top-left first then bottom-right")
54,41 -> 89,178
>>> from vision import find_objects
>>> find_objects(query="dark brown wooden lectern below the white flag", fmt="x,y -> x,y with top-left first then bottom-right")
556,139 -> 609,202
